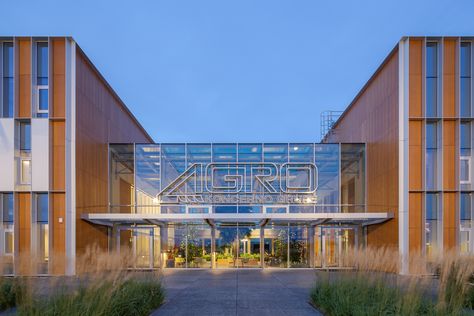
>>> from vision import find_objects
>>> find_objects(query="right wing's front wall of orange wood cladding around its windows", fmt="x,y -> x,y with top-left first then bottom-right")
408,37 -> 460,255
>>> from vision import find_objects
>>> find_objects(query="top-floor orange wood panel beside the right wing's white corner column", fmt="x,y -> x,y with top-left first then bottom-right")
408,39 -> 424,117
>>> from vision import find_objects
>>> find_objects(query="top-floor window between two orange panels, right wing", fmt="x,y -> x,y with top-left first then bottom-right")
426,42 -> 438,117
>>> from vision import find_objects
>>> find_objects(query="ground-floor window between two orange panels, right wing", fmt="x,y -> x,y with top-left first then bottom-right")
425,193 -> 442,256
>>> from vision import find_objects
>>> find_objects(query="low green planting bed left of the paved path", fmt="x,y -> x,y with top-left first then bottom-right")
0,272 -> 164,315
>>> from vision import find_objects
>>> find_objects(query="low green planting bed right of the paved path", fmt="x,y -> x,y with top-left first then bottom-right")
310,252 -> 474,316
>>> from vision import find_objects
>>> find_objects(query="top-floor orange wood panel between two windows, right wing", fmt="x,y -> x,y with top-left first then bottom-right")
442,38 -> 458,117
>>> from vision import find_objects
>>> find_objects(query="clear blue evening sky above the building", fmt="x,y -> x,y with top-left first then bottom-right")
0,0 -> 474,142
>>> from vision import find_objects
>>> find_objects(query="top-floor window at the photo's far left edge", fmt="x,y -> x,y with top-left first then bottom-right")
0,42 -> 13,117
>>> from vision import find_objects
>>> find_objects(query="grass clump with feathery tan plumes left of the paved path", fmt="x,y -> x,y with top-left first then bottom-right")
0,245 -> 164,315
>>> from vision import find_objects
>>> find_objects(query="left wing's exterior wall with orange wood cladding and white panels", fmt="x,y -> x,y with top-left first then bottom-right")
0,37 -> 151,275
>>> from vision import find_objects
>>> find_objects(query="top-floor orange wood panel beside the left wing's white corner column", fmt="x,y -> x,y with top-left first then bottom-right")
50,38 -> 66,118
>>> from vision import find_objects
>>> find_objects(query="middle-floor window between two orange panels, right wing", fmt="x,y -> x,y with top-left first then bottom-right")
425,122 -> 438,190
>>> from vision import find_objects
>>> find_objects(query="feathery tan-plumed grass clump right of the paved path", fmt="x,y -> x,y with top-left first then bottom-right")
313,247 -> 474,315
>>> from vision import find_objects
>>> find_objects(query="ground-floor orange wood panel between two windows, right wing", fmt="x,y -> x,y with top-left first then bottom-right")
443,192 -> 459,250
